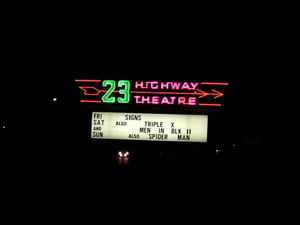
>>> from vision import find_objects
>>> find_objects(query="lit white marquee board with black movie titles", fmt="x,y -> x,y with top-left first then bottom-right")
91,112 -> 208,142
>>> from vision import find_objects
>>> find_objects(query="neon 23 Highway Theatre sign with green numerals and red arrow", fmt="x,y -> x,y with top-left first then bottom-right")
75,79 -> 229,107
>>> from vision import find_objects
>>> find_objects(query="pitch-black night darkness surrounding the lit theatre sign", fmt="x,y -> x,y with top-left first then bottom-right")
0,7 -> 300,219
